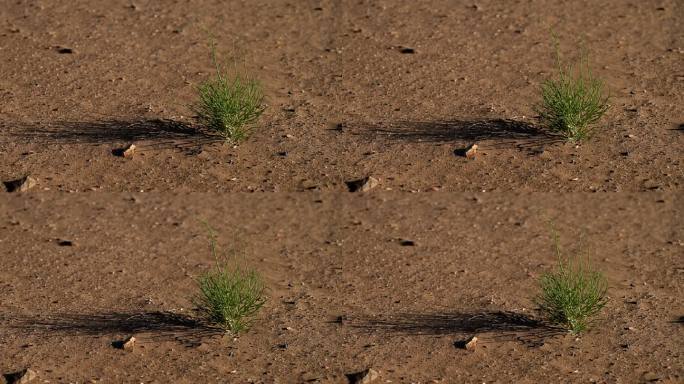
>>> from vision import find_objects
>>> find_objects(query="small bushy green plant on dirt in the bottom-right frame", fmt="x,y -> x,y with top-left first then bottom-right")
535,233 -> 608,333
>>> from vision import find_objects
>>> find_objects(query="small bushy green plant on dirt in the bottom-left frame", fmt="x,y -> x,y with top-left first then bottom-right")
193,229 -> 266,334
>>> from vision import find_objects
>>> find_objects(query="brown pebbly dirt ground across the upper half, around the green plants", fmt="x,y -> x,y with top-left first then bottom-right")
0,0 -> 684,192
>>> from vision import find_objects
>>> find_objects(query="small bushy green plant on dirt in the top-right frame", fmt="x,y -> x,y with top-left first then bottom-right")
535,40 -> 610,141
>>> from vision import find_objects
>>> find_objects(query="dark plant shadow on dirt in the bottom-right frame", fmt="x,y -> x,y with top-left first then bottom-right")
353,311 -> 567,347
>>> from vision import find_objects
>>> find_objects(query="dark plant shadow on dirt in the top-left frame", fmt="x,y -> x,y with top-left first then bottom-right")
5,119 -> 224,154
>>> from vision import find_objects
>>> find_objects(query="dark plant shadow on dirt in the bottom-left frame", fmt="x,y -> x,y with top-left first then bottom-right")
3,311 -> 225,346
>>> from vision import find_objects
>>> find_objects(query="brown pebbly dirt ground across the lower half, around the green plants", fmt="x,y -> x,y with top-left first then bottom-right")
0,193 -> 684,383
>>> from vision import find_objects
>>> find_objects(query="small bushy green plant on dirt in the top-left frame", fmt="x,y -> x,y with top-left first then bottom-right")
193,43 -> 265,143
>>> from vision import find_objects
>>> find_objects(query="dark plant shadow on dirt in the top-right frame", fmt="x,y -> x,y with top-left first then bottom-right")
354,119 -> 564,149
